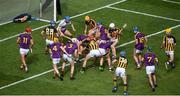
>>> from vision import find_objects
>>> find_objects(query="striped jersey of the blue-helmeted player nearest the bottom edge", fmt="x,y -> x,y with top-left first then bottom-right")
116,57 -> 128,69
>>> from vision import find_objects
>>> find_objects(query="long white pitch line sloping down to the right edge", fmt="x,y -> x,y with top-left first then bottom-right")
107,6 -> 180,22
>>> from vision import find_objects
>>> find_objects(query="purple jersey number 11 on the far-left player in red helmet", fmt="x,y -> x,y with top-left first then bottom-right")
18,33 -> 32,49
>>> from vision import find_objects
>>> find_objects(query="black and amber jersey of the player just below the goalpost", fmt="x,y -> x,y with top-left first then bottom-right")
44,26 -> 57,40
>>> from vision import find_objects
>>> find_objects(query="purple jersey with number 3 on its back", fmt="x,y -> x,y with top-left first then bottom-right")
65,43 -> 78,54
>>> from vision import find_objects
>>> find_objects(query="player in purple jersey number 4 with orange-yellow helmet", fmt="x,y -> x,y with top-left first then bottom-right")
50,37 -> 67,80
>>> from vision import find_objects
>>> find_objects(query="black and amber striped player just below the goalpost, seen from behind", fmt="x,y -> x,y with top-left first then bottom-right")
41,21 -> 59,53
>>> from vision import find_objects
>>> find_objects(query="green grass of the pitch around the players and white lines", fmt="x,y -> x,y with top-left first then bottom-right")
0,0 -> 180,95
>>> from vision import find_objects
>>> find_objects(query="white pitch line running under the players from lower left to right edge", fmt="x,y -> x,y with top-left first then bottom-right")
0,25 -> 180,90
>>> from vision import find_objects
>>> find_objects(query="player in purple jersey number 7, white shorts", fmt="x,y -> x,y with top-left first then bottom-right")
142,47 -> 158,92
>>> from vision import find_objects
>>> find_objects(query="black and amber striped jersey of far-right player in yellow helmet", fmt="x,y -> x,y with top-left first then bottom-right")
163,35 -> 176,51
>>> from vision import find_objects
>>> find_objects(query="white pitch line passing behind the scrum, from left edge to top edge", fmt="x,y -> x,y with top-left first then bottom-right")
0,0 -> 127,43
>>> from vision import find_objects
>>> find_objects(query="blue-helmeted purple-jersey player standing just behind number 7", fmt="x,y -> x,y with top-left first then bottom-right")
133,27 -> 147,69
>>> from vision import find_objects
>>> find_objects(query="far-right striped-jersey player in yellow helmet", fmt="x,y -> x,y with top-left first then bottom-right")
161,28 -> 176,70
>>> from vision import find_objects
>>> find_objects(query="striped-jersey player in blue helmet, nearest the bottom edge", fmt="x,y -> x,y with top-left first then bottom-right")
112,51 -> 128,95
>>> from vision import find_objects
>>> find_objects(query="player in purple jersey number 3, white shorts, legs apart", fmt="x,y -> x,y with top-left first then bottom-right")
61,41 -> 78,80
